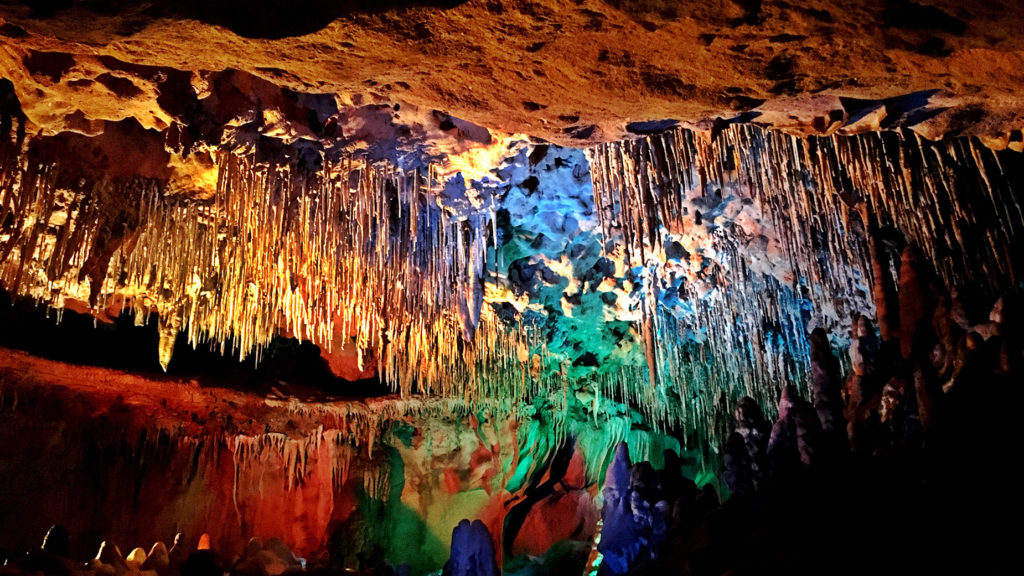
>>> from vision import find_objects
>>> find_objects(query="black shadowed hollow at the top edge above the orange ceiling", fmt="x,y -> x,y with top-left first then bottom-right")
25,0 -> 465,39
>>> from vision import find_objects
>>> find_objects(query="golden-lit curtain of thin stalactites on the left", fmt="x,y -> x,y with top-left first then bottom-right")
0,130 -> 546,400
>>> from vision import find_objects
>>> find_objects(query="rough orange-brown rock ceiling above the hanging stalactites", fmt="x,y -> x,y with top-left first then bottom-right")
6,0 -> 1024,146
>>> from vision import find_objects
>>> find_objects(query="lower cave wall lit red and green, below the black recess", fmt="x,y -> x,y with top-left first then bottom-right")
0,348 -> 678,573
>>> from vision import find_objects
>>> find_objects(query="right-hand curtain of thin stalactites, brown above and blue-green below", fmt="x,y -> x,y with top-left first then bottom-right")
588,124 -> 1024,453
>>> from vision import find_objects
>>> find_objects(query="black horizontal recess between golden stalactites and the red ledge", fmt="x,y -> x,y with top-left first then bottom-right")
0,290 -> 390,399
